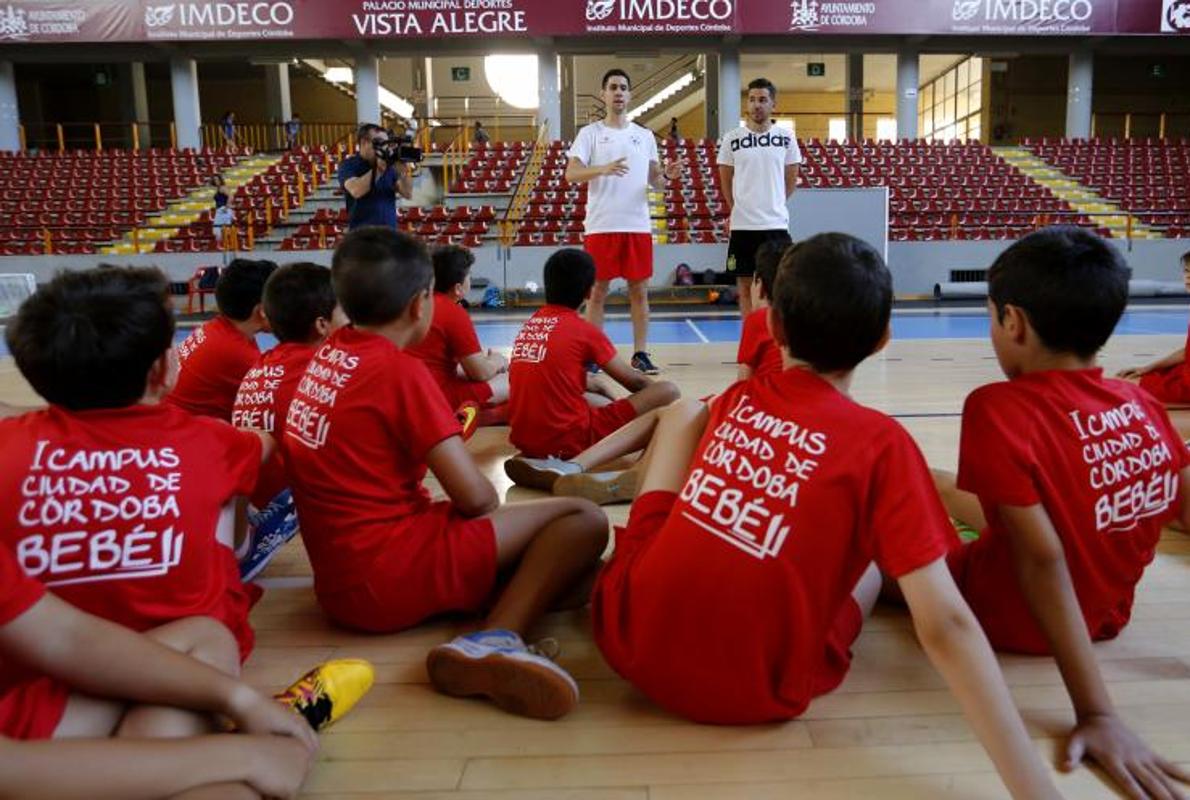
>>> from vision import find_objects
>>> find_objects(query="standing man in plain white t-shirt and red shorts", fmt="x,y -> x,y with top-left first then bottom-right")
566,69 -> 681,375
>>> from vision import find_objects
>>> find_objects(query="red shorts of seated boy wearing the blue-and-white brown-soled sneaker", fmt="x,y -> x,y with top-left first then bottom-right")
314,500 -> 497,633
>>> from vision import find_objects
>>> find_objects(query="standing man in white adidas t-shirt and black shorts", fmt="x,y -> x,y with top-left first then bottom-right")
719,77 -> 802,318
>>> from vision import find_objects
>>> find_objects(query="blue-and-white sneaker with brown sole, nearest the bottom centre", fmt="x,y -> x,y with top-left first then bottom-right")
426,631 -> 578,719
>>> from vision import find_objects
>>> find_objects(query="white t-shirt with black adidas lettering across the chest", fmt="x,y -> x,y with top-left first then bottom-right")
719,125 -> 802,231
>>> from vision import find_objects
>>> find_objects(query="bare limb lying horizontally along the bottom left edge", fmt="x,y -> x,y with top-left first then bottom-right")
0,735 -> 311,800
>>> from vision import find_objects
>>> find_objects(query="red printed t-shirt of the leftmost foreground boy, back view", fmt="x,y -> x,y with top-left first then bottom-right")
0,405 -> 261,656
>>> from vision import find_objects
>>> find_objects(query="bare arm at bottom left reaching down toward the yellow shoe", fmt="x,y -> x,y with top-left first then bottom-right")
0,594 -> 318,750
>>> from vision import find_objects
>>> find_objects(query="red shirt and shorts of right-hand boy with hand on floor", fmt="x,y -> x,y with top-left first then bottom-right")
956,369 -> 1186,654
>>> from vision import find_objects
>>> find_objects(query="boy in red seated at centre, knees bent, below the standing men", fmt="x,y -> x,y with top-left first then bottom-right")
505,248 -> 681,502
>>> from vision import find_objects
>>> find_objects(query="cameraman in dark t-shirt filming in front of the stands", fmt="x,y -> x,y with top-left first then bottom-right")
339,123 -> 413,230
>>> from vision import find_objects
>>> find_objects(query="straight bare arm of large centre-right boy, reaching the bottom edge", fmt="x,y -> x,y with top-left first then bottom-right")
897,558 -> 1061,800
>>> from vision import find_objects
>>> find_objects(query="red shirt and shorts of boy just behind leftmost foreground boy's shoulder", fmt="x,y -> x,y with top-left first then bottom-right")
231,342 -> 314,508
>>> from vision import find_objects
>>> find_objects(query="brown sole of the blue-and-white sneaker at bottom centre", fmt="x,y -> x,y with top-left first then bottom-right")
426,648 -> 578,719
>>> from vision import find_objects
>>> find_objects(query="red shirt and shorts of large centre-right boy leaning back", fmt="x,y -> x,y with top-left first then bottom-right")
601,369 -> 956,723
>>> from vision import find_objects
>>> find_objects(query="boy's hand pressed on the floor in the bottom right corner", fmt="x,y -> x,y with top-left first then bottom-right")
1061,714 -> 1190,800
